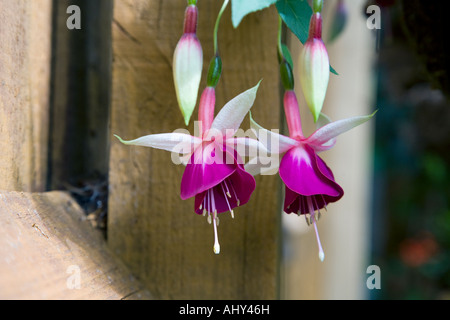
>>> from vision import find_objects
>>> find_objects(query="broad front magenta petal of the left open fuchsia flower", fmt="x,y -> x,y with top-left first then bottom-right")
180,143 -> 236,200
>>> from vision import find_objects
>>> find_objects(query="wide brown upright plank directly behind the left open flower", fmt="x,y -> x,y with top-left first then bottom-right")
108,0 -> 280,299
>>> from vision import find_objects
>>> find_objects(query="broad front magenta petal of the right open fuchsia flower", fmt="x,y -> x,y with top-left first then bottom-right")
279,145 -> 343,197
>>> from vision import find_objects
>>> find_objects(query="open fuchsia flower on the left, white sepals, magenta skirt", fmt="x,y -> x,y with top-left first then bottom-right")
116,84 -> 265,254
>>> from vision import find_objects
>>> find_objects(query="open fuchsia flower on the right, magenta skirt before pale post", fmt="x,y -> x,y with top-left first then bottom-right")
250,90 -> 375,261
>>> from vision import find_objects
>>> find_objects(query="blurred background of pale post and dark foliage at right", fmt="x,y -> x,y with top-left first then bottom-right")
282,0 -> 450,299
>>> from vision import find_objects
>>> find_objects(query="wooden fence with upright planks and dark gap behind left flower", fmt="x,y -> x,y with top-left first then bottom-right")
0,0 -> 280,299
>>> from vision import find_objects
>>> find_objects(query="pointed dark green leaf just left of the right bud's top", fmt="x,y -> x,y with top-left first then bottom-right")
276,0 -> 339,75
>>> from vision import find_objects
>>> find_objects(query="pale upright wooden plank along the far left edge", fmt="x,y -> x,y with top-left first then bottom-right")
0,0 -> 52,191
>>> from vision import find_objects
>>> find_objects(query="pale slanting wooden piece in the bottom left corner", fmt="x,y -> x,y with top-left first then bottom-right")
0,191 -> 150,300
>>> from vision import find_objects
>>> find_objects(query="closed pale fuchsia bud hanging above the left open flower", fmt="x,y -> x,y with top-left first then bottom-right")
173,4 -> 203,125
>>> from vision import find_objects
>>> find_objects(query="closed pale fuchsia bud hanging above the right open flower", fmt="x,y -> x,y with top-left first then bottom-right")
299,12 -> 330,122
